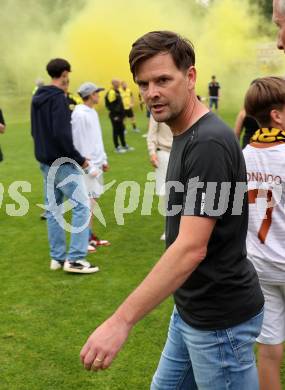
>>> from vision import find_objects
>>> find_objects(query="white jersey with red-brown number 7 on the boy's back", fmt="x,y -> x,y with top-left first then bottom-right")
243,143 -> 285,282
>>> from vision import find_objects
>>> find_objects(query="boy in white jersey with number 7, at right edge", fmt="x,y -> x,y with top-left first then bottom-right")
243,77 -> 285,390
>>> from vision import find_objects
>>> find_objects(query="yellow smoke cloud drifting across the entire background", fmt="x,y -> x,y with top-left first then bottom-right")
0,0 -> 285,114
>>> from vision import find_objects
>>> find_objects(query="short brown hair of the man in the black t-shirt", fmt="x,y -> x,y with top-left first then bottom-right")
129,31 -> 195,79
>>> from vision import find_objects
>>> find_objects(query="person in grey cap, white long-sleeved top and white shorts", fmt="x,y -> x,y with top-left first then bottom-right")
71,82 -> 110,252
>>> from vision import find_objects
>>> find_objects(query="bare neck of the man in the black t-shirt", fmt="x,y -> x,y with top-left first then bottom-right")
167,95 -> 209,135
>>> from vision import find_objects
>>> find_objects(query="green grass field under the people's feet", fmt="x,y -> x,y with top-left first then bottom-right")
0,107 -> 285,390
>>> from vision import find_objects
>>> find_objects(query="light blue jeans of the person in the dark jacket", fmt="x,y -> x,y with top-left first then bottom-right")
40,163 -> 90,262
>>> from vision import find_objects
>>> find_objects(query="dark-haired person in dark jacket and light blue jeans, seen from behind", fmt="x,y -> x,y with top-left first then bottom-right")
31,58 -> 98,273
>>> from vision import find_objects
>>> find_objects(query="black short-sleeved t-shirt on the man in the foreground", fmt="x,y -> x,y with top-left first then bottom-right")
166,113 -> 264,330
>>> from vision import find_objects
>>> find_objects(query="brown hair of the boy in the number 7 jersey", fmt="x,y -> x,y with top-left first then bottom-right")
244,77 -> 285,127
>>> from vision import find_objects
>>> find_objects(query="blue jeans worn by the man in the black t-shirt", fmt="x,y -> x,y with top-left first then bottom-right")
151,307 -> 263,390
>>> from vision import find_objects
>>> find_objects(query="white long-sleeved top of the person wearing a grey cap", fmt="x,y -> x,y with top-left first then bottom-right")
71,104 -> 107,166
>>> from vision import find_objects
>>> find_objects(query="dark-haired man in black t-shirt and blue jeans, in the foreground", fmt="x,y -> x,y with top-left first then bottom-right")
81,31 -> 264,390
